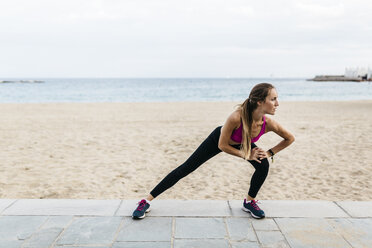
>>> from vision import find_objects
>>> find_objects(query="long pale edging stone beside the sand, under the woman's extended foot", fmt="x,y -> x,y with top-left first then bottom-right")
116,200 -> 231,217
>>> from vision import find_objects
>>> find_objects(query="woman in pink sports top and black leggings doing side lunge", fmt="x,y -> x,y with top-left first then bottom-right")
132,83 -> 295,219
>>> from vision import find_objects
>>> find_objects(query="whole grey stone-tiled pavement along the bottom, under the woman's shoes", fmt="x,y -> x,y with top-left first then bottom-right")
0,199 -> 372,248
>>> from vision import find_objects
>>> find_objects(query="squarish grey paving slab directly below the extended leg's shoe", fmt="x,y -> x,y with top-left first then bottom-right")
116,217 -> 172,242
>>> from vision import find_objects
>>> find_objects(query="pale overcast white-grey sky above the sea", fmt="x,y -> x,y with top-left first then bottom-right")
0,0 -> 372,77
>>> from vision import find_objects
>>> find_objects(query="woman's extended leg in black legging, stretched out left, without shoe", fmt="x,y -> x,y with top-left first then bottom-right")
150,127 -> 221,199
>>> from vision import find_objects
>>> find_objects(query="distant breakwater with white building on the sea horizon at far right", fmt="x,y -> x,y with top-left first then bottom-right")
307,67 -> 372,82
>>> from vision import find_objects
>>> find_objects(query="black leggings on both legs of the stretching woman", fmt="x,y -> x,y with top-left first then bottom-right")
150,126 -> 269,198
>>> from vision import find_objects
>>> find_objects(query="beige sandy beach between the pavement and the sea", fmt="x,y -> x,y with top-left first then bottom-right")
0,100 -> 372,201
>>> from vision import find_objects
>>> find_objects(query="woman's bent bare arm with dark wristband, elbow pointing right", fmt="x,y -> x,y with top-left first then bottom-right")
266,117 -> 295,157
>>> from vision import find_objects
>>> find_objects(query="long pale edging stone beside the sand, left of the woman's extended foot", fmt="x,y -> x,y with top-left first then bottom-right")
2,199 -> 120,216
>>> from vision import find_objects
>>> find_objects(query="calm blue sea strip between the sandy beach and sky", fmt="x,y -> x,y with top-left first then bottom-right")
0,78 -> 372,103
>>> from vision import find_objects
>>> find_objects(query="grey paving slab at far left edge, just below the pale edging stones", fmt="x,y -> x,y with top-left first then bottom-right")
0,216 -> 48,244
